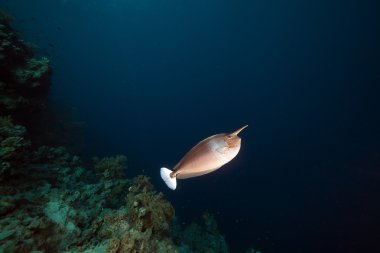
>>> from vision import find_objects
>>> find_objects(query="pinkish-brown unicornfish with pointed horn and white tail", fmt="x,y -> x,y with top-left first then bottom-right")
160,125 -> 248,190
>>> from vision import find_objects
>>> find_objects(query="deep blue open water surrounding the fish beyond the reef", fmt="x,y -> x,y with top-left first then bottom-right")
0,0 -> 380,253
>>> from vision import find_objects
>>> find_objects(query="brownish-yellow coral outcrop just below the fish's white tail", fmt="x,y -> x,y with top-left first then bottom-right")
71,176 -> 178,252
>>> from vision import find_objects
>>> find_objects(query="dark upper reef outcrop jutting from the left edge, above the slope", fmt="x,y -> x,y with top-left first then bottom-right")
0,12 -> 52,114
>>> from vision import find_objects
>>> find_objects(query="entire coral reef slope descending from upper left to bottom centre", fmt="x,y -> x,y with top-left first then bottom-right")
0,9 -> 258,253
